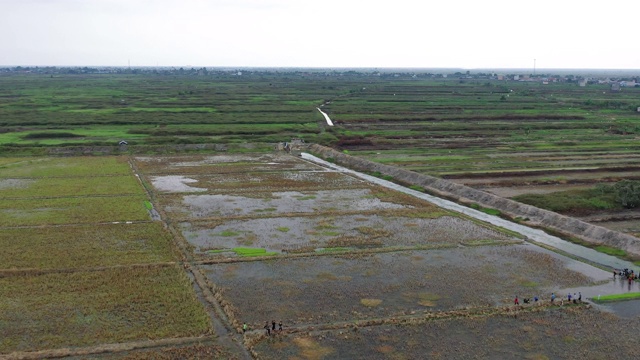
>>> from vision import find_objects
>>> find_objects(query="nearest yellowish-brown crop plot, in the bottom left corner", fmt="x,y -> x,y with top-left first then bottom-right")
0,265 -> 210,353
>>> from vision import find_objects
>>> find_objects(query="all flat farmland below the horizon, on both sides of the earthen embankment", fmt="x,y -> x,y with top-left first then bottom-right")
0,72 -> 640,359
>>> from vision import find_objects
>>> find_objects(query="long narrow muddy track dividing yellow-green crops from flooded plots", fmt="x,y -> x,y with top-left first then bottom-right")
129,157 -> 252,359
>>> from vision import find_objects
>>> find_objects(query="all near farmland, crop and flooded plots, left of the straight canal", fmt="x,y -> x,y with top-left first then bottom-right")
0,152 -> 640,359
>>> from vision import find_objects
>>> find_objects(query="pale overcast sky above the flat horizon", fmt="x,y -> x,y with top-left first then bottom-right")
0,0 -> 640,69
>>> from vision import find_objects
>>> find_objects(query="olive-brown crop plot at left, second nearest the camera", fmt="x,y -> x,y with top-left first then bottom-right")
0,222 -> 176,269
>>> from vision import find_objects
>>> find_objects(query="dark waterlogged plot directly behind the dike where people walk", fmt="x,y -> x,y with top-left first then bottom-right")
203,245 -> 598,328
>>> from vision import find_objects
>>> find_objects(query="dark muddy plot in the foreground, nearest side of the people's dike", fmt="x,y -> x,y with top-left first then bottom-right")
256,307 -> 640,360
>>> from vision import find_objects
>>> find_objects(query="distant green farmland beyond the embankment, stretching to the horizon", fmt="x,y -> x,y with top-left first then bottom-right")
0,69 -> 640,234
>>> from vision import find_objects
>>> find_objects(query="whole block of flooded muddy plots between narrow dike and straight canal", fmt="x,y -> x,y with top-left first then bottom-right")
129,154 -> 635,359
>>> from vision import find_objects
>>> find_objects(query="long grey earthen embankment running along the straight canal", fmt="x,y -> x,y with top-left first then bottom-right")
309,144 -> 640,258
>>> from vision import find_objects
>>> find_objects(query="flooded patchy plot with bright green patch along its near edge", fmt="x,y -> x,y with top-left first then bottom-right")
181,215 -> 516,253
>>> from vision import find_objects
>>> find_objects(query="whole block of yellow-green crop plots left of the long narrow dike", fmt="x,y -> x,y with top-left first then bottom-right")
0,157 -> 212,357
